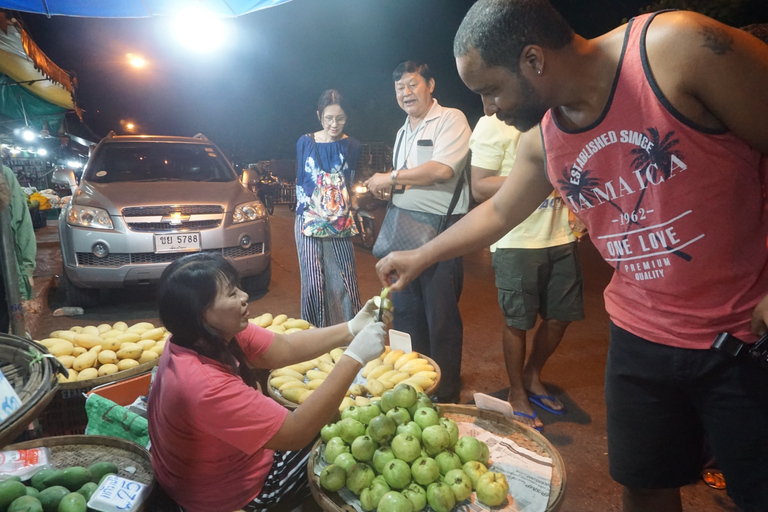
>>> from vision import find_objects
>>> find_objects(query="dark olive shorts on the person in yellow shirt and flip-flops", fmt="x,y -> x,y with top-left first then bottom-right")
493,242 -> 584,331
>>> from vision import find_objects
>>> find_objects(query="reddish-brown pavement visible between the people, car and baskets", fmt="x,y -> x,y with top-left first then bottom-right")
25,205 -> 737,512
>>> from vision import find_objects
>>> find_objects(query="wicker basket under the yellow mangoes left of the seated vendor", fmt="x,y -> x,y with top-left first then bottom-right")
39,359 -> 159,437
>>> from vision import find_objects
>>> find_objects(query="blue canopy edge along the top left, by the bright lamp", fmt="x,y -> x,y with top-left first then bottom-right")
0,0 -> 290,18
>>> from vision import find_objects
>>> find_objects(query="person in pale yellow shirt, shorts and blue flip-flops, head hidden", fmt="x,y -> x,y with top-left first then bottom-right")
469,116 -> 584,430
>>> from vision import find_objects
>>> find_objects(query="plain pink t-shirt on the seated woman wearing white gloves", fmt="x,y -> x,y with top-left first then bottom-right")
148,324 -> 288,512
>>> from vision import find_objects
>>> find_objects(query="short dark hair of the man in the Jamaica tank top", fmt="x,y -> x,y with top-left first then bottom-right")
453,0 -> 573,73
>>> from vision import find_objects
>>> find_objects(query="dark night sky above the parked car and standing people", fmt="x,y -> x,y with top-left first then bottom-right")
20,0 -> 647,163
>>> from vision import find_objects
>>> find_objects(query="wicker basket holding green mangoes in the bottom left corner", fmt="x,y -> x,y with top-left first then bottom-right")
5,436 -> 155,512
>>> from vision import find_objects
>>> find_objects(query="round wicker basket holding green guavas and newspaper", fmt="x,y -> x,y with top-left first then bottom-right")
307,404 -> 566,512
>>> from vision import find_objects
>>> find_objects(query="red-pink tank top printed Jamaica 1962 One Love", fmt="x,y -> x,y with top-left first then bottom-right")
541,15 -> 768,349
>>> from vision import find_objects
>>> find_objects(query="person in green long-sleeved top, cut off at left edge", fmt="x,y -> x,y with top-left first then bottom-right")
0,165 -> 37,332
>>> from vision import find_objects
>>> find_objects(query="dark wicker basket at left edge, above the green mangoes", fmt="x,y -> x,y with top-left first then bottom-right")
0,333 -> 63,446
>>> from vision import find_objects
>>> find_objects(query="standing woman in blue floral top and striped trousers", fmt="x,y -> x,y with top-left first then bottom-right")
294,89 -> 361,327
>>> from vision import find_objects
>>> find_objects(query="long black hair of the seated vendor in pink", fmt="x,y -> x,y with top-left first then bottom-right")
157,252 -> 257,388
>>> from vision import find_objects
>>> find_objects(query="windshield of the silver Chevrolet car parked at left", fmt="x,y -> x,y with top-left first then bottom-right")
85,142 -> 237,183
